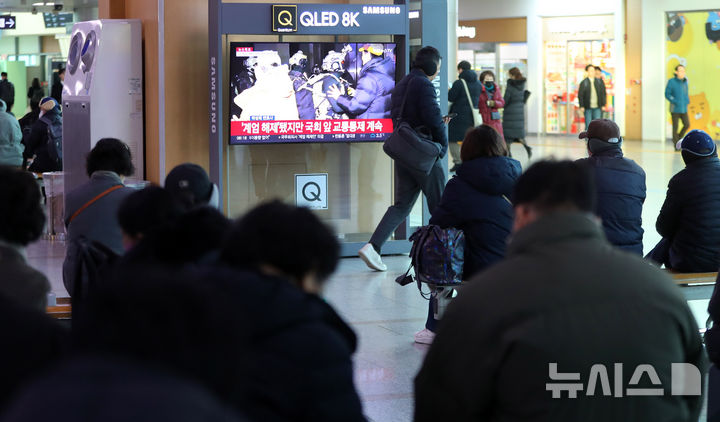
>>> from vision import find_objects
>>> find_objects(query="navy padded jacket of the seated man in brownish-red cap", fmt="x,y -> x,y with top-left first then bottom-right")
578,148 -> 646,255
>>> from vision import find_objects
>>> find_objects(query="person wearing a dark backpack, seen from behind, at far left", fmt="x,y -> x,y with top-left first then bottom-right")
24,97 -> 62,173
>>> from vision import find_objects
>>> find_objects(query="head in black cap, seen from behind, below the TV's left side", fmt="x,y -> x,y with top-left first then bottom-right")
165,163 -> 220,209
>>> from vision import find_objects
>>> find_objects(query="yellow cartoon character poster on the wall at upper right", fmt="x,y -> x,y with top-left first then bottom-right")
665,10 -> 720,140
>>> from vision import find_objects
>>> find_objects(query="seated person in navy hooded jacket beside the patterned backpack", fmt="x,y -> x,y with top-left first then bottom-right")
415,125 -> 522,344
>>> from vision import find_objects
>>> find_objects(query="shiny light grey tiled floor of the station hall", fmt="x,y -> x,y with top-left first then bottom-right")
27,136 -> 709,422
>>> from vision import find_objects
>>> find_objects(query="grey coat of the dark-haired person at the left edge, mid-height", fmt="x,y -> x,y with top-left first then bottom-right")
0,242 -> 50,312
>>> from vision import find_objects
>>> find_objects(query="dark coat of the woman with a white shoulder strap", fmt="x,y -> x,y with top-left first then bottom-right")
448,70 -> 482,142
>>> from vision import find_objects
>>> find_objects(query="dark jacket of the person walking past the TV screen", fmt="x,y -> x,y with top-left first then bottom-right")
392,68 -> 448,158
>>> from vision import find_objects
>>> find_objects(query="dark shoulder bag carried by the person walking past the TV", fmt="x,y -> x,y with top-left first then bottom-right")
383,80 -> 442,175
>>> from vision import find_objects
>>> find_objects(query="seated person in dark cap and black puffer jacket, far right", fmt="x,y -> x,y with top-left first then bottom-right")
646,130 -> 720,273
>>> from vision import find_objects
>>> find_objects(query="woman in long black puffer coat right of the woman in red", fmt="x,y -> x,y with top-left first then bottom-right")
503,67 -> 532,158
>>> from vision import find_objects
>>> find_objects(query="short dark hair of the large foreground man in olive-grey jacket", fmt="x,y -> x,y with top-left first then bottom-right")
513,160 -> 596,213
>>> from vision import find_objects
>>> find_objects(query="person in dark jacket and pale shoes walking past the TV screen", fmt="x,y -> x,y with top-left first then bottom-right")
358,46 -> 450,271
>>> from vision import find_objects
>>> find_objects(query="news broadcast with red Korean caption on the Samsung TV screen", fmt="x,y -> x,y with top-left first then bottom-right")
230,43 -> 398,145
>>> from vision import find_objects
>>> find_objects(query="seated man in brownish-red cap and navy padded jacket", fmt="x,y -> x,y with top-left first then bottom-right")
578,119 -> 646,255
